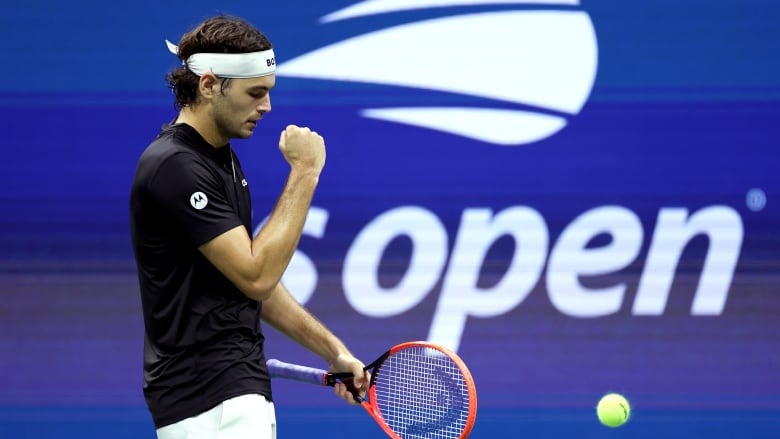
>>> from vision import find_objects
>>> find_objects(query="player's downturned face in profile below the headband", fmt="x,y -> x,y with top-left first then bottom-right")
211,75 -> 276,139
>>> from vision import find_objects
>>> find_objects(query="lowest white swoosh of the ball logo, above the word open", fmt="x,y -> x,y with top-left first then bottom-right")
361,107 -> 566,145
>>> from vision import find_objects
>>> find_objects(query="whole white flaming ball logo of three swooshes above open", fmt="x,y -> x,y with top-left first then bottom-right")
276,0 -> 598,145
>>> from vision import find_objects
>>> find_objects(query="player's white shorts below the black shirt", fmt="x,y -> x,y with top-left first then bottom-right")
157,394 -> 276,439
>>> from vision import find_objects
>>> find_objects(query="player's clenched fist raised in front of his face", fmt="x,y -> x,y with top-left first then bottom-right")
279,125 -> 325,173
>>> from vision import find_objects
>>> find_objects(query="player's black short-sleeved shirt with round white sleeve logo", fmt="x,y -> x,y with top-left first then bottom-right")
130,124 -> 271,428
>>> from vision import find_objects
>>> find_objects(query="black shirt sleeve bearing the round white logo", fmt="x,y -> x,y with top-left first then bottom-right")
149,153 -> 242,247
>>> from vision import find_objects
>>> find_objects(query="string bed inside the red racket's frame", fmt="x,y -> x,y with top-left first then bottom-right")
375,346 -> 469,439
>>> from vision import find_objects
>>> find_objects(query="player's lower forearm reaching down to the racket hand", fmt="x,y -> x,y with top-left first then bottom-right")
261,283 -> 352,365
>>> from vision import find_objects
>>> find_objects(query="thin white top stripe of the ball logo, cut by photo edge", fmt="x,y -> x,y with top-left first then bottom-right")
320,0 -> 580,23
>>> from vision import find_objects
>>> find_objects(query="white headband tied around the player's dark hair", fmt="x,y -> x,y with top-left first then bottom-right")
165,40 -> 276,78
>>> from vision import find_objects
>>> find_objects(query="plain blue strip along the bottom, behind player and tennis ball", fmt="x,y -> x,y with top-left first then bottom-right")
0,407 -> 780,439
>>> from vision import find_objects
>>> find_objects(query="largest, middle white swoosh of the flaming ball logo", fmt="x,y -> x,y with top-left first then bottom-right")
276,11 -> 598,114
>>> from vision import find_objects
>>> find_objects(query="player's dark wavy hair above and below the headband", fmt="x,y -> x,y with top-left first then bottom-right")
165,15 -> 273,110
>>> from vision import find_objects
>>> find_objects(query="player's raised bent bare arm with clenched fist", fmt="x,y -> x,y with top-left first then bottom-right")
199,125 -> 325,301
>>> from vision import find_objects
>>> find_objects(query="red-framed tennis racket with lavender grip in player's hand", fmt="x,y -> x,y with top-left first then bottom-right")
267,341 -> 477,439
